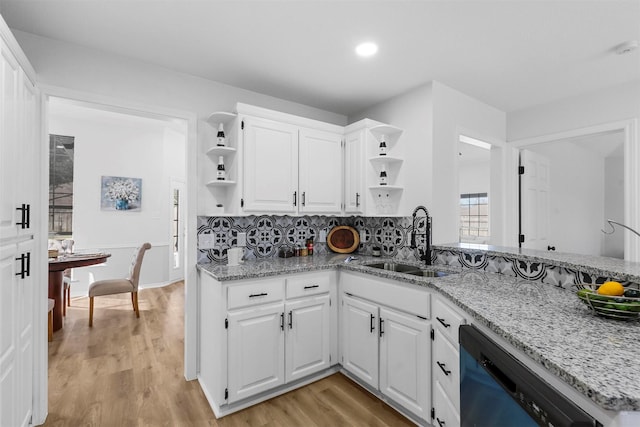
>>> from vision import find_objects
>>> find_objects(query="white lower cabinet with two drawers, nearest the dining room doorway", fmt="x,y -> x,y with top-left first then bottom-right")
198,272 -> 337,416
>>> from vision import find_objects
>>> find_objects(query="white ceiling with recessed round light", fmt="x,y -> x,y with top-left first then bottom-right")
0,0 -> 640,115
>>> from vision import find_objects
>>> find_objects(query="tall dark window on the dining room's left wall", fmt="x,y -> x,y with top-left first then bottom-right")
49,135 -> 75,237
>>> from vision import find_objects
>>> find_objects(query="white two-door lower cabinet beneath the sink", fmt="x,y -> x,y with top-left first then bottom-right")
340,277 -> 431,420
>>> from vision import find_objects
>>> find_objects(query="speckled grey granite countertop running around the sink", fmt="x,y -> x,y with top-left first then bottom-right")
198,252 -> 640,411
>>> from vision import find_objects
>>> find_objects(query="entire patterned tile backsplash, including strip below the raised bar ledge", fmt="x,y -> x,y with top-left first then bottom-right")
198,215 -> 628,288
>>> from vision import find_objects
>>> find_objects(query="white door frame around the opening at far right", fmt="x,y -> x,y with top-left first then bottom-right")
507,119 -> 640,262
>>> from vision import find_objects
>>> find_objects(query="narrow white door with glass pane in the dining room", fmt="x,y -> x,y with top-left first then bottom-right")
169,180 -> 187,282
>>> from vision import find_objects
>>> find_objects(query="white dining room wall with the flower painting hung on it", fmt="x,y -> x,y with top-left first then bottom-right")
49,102 -> 185,295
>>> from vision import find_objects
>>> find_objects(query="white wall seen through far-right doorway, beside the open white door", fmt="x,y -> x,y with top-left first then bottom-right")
527,142 -> 604,255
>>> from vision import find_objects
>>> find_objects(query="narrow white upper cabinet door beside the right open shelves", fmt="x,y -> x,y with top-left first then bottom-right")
344,130 -> 365,214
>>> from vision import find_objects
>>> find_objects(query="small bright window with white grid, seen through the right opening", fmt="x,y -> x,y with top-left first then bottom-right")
460,193 -> 489,242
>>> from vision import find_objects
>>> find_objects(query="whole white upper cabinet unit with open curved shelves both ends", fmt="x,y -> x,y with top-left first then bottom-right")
200,104 -> 403,216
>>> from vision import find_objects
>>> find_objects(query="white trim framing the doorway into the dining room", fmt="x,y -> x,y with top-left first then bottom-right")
40,85 -> 198,380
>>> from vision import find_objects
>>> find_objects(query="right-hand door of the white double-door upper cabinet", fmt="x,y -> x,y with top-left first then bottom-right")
298,129 -> 342,214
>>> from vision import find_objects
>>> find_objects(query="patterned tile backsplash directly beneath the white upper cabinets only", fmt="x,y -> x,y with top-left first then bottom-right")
198,215 -> 425,263
